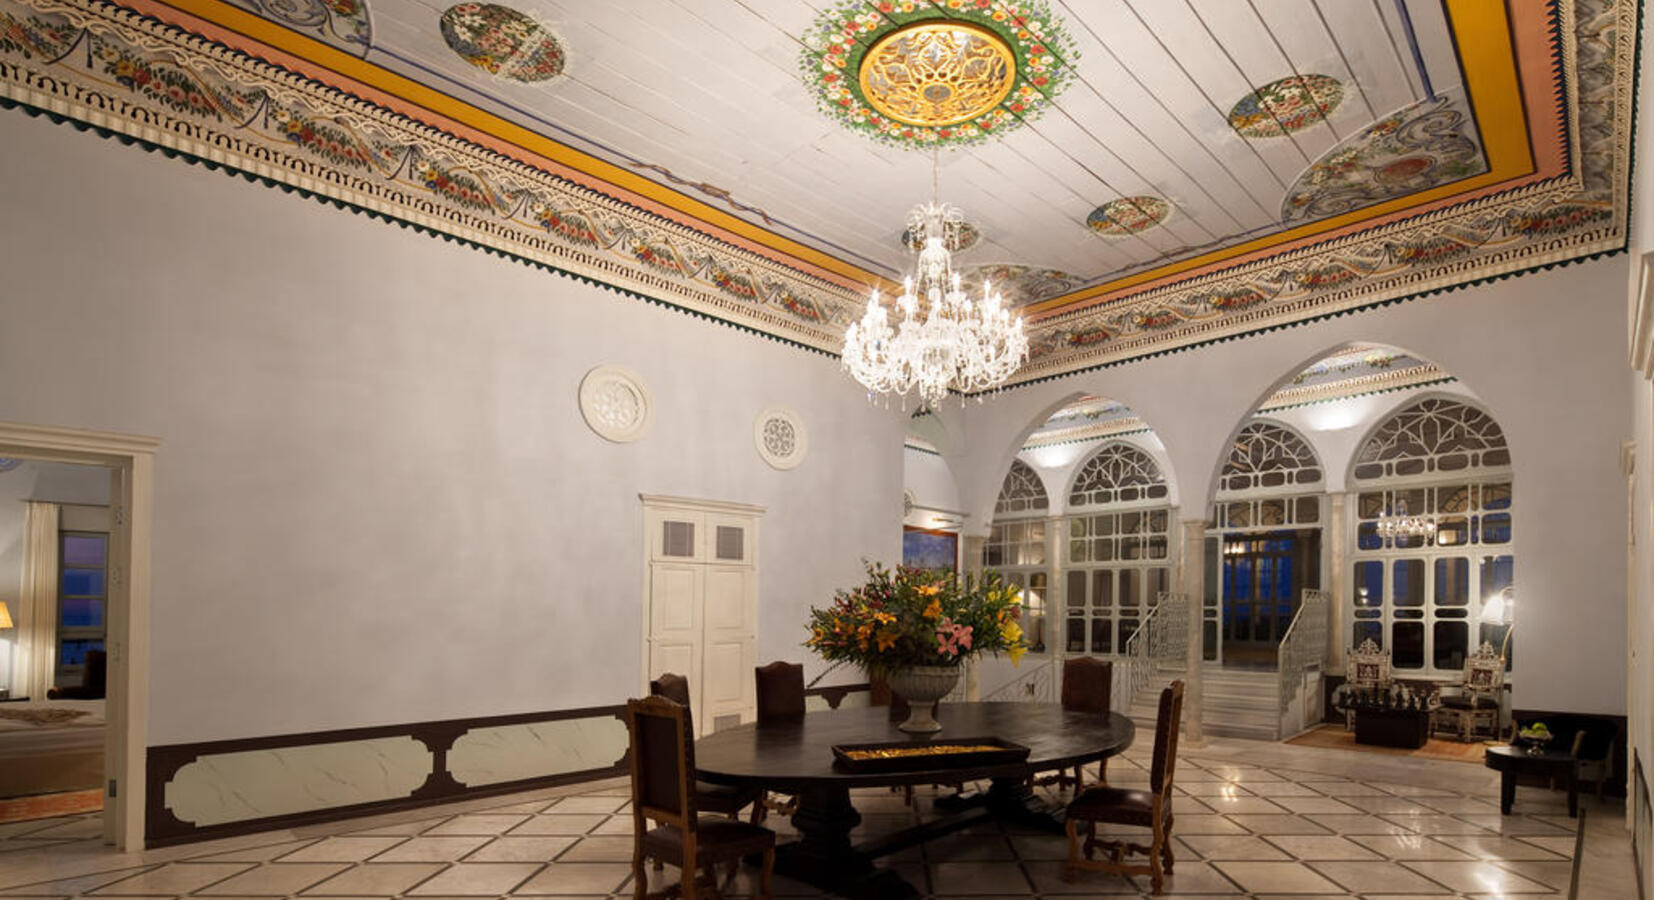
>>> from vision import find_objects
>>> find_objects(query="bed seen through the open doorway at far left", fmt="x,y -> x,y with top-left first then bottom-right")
0,700 -> 104,799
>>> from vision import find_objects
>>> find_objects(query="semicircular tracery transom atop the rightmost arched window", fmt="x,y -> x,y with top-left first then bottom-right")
1353,397 -> 1510,481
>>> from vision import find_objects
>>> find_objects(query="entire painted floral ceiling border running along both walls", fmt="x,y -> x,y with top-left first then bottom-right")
0,0 -> 1641,384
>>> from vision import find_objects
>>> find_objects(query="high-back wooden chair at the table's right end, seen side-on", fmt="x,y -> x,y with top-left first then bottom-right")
1064,682 -> 1183,893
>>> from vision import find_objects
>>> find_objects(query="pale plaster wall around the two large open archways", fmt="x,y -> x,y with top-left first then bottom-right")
944,256 -> 1631,713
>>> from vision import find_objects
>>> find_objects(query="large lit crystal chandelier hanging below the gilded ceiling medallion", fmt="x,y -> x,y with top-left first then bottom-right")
844,186 -> 1029,409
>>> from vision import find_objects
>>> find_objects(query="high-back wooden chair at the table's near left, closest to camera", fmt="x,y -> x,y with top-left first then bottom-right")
625,697 -> 776,900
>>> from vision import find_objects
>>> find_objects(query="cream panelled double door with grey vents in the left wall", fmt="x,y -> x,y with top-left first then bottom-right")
645,505 -> 761,735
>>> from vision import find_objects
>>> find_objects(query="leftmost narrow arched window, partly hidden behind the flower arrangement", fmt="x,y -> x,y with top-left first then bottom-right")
982,460 -> 1050,653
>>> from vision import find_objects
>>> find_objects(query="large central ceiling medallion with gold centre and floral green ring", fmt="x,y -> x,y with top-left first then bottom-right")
801,0 -> 1078,147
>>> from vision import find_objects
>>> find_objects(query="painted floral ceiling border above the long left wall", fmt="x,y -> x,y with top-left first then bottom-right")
0,0 -> 862,354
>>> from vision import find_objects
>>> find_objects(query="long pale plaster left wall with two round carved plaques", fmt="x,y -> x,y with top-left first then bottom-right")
0,113 -> 905,744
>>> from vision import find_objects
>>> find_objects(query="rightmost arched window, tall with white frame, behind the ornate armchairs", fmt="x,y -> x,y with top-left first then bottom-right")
1350,397 -> 1513,675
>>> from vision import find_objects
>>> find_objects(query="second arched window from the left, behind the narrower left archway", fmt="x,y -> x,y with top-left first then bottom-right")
1062,440 -> 1171,653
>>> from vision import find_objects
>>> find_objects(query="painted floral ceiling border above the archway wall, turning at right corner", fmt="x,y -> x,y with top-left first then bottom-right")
1016,0 -> 1639,385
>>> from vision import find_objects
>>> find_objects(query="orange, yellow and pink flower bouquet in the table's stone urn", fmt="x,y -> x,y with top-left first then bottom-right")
804,563 -> 1027,675
